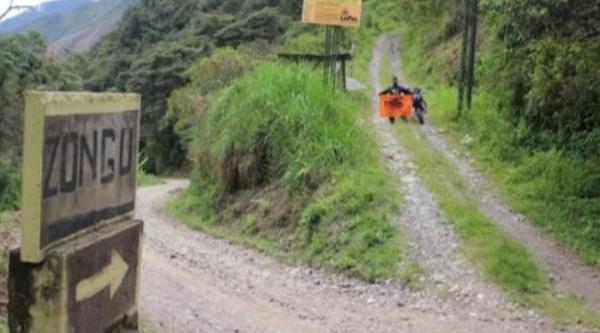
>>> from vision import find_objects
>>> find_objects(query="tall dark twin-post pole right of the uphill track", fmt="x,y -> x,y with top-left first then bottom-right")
457,0 -> 479,117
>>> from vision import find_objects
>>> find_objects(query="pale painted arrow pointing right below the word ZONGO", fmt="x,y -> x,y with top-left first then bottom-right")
75,250 -> 129,302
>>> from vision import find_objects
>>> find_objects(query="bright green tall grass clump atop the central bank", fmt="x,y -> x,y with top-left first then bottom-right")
195,65 -> 369,189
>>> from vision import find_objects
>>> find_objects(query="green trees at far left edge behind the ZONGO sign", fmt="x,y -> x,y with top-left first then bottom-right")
0,32 -> 82,211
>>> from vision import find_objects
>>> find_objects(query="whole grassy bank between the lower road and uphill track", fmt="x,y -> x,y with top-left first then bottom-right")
171,64 -> 403,281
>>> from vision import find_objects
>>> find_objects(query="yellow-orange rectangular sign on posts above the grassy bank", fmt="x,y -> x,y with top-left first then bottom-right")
302,0 -> 362,27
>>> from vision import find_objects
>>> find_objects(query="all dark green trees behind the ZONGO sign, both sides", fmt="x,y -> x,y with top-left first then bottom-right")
0,0 -> 301,205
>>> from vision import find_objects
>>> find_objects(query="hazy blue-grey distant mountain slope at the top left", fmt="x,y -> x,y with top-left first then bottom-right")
0,0 -> 137,51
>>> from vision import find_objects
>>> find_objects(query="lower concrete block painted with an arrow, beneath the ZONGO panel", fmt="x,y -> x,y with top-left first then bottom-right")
9,221 -> 143,333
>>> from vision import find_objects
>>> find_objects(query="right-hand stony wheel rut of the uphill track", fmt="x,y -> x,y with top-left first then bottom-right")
384,34 -> 600,310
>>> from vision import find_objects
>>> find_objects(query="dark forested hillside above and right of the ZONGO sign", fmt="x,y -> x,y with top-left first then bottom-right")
84,0 -> 300,172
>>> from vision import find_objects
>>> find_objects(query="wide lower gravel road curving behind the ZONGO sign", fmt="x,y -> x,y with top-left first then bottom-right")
137,180 -> 564,333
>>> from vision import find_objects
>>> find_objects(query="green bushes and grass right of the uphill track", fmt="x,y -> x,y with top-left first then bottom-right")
394,0 -> 600,267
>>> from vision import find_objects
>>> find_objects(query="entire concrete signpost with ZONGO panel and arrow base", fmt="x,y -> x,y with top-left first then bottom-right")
8,92 -> 143,333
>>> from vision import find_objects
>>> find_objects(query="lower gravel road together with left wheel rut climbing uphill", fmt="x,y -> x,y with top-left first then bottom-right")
137,34 -> 596,333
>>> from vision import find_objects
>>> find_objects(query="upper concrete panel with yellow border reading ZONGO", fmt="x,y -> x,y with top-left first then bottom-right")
21,92 -> 140,263
